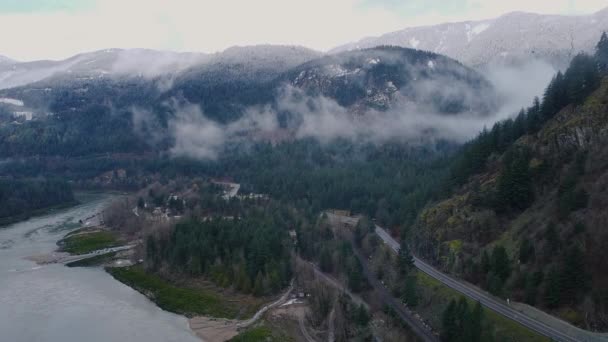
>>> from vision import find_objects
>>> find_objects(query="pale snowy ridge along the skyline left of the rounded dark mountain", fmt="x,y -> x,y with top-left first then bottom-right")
0,45 -> 320,89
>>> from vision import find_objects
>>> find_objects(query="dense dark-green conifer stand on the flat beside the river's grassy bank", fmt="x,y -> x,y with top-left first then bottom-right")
145,196 -> 298,296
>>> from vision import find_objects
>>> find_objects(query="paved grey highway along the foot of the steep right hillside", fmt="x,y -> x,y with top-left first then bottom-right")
376,225 -> 607,342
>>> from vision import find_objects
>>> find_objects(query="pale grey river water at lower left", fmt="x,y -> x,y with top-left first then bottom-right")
0,195 -> 198,342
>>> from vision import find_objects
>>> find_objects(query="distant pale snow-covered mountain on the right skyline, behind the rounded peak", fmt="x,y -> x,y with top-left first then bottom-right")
331,8 -> 608,68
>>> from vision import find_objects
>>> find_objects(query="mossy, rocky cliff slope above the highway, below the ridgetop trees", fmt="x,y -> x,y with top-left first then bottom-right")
414,78 -> 608,330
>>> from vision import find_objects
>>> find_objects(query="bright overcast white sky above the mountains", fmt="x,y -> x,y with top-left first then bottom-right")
0,0 -> 608,61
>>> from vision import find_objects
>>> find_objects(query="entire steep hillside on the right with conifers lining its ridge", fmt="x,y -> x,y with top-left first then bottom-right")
411,34 -> 608,330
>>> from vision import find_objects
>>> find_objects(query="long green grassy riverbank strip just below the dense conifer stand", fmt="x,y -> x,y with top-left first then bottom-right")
106,266 -> 262,319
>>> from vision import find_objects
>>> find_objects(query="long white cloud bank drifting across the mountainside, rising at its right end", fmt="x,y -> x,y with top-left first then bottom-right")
140,57 -> 554,159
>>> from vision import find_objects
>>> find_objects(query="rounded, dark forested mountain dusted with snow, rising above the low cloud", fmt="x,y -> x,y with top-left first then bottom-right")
282,47 -> 497,114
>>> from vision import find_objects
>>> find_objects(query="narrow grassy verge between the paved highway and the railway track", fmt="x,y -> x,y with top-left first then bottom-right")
416,272 -> 550,342
